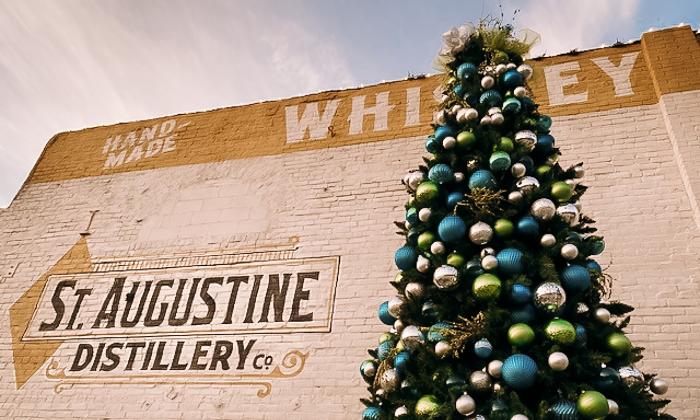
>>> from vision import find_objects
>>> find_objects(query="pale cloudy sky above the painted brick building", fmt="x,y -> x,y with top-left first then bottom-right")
0,0 -> 700,207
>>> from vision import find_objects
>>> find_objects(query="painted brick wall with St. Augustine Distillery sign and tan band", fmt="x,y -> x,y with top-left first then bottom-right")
0,27 -> 700,419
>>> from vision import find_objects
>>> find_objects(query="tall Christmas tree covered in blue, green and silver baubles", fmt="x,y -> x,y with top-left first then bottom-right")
360,22 -> 673,420
